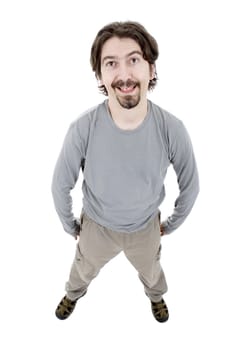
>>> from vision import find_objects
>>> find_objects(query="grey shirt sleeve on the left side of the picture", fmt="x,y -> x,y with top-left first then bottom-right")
52,123 -> 83,235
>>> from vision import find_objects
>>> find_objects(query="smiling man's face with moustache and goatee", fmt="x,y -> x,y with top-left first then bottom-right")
100,37 -> 154,109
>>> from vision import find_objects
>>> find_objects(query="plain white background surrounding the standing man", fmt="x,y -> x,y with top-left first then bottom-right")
0,0 -> 233,350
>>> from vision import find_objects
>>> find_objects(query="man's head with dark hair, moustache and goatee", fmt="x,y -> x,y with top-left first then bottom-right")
90,21 -> 159,108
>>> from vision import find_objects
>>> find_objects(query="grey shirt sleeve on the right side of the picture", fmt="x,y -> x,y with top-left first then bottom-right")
162,120 -> 199,234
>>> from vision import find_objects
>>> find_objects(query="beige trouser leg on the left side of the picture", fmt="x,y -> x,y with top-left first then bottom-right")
66,213 -> 122,300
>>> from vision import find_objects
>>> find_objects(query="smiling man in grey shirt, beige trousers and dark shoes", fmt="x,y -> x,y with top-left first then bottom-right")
52,22 -> 199,322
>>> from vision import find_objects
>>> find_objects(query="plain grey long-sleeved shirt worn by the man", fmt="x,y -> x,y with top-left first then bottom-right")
52,100 -> 199,235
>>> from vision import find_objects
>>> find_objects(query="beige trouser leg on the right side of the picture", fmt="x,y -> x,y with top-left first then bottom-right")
124,216 -> 167,302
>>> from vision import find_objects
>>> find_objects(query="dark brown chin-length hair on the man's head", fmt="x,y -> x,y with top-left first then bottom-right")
90,21 -> 159,95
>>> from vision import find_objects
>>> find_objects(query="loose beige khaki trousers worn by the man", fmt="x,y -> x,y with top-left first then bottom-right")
66,212 -> 167,302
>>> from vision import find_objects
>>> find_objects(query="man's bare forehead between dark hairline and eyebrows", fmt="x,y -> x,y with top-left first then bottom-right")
101,37 -> 142,61
